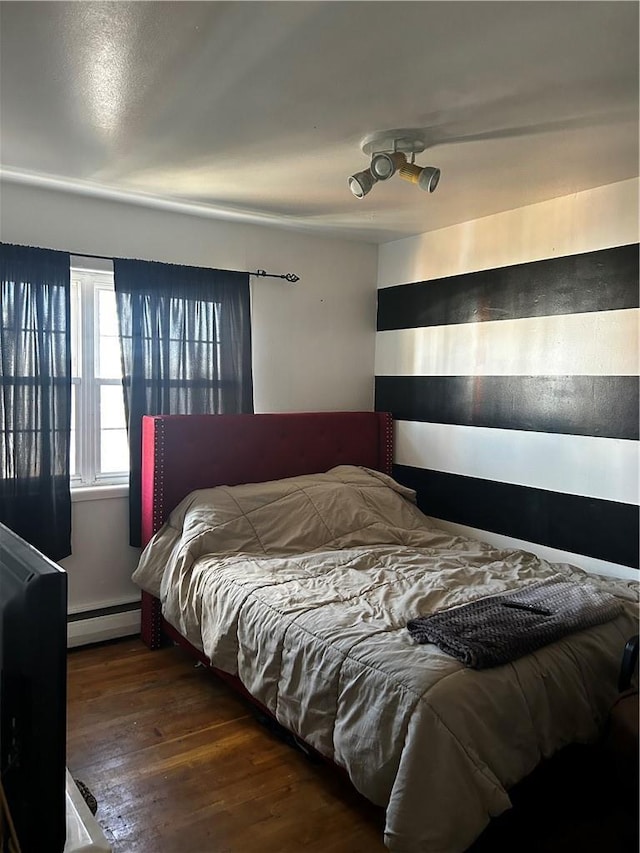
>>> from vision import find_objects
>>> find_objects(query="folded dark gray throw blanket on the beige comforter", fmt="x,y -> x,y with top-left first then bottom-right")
407,575 -> 622,669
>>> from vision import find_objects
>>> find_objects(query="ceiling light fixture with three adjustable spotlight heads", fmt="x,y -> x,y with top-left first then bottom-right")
349,130 -> 440,198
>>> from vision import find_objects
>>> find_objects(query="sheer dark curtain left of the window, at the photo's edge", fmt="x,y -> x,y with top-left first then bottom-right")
0,243 -> 71,560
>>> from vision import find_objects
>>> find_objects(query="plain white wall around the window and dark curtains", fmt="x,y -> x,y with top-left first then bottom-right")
0,183 -> 377,624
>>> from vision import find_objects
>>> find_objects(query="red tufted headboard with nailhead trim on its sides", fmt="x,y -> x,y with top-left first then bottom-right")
142,412 -> 393,544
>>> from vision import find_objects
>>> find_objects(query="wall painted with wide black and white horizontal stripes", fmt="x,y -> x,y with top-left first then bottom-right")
375,244 -> 640,577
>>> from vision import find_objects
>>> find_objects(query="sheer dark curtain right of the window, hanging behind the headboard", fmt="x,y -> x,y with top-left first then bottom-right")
113,259 -> 253,546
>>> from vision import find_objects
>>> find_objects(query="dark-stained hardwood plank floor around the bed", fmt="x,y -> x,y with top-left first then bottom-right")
67,639 -> 638,853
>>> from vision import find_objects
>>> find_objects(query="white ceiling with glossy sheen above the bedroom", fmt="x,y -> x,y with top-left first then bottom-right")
0,0 -> 638,242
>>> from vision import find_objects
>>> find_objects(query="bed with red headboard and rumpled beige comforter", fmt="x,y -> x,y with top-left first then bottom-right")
134,412 -> 637,853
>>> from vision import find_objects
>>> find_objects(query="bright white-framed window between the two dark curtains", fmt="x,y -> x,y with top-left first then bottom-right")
70,264 -> 129,488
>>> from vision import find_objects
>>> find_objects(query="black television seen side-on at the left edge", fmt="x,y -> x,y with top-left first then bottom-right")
0,524 -> 67,853
